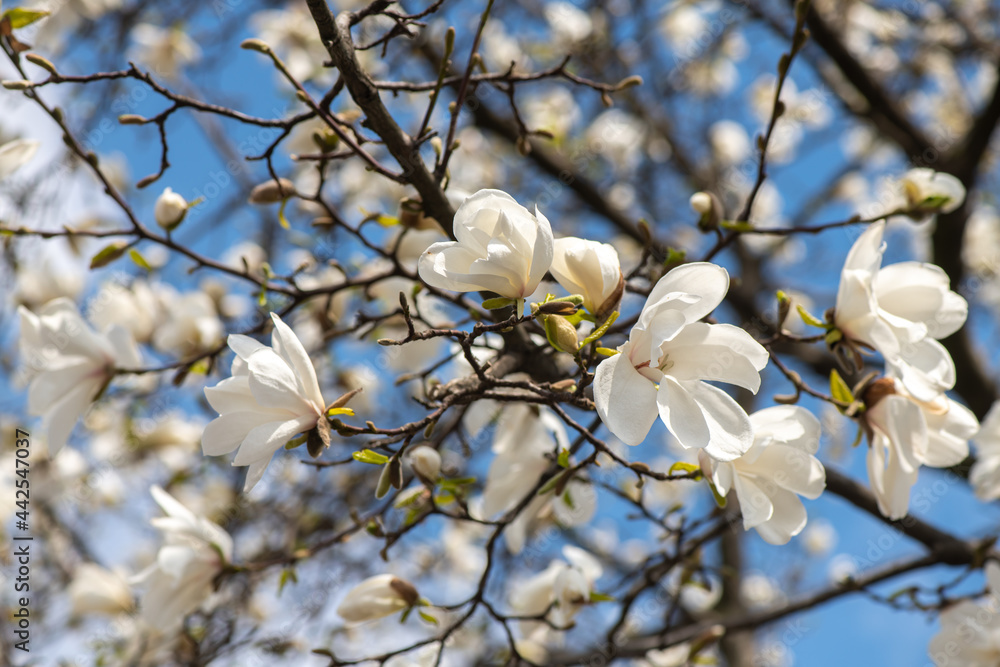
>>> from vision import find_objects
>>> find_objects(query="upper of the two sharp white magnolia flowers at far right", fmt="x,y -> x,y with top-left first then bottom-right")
834,222 -> 969,400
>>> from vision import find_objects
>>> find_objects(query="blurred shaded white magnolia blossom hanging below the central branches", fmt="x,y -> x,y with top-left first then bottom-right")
482,403 -> 597,554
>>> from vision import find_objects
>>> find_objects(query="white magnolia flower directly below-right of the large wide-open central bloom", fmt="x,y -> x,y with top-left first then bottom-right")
699,405 -> 826,544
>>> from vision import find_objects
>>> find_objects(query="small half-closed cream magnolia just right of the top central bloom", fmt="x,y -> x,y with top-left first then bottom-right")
549,236 -> 625,319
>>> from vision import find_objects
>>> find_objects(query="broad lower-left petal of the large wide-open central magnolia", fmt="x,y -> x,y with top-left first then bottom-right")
594,343 -> 657,445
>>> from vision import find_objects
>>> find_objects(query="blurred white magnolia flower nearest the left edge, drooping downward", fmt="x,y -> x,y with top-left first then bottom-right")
18,298 -> 139,455
